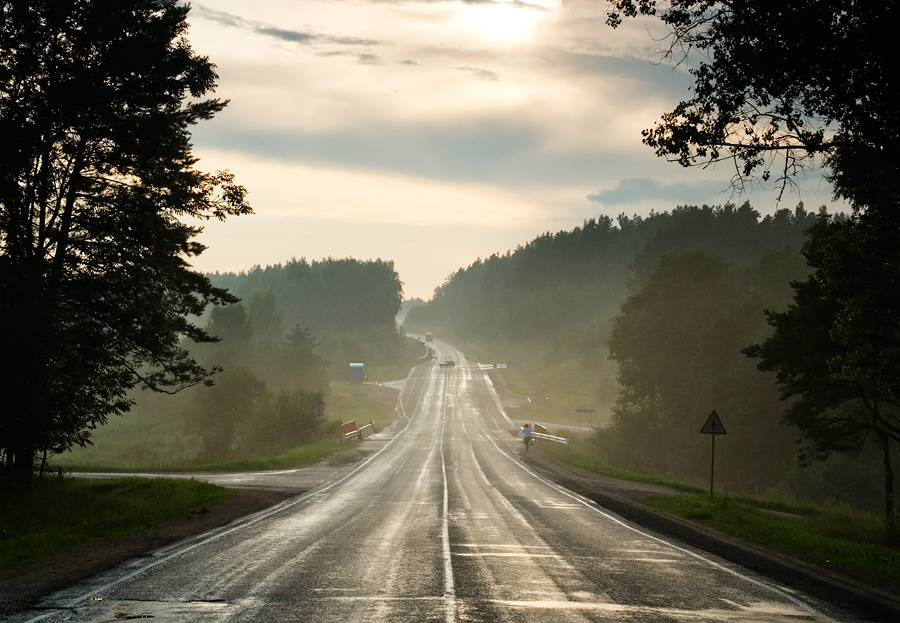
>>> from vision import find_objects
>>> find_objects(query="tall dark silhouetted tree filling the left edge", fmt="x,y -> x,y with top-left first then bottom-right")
0,0 -> 251,481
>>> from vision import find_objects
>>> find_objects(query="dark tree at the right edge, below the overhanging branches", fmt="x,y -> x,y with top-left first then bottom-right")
744,215 -> 900,544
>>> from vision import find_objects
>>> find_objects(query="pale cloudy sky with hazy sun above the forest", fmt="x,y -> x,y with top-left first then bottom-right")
181,0 -> 831,300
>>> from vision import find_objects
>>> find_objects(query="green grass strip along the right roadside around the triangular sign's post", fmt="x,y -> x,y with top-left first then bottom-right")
536,435 -> 900,588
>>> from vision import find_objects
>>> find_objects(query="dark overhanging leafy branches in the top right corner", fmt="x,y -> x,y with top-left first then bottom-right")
607,0 -> 900,209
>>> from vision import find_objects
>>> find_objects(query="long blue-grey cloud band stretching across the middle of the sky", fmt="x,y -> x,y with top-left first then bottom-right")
192,117 -> 646,189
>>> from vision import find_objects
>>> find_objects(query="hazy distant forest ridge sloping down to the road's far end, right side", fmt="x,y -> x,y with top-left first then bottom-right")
405,204 -> 813,344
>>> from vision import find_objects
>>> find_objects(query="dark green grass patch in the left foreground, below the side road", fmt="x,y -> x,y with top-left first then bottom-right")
0,477 -> 231,570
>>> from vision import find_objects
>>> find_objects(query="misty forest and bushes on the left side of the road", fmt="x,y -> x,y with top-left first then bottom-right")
63,258 -> 405,465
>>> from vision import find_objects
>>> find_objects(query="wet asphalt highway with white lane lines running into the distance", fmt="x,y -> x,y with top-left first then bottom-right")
10,341 -> 872,623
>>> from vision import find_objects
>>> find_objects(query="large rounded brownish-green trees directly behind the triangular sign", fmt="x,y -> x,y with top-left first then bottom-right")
598,250 -> 804,490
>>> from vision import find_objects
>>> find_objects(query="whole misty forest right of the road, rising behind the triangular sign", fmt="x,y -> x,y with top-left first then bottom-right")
405,203 -> 900,510
